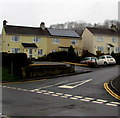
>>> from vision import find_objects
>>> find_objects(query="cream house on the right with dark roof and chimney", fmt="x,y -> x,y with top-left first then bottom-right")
82,25 -> 120,54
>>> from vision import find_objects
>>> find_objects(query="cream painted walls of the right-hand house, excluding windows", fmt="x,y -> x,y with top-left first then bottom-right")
82,28 -> 119,54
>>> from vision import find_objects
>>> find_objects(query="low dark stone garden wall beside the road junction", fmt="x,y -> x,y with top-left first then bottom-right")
22,64 -> 75,78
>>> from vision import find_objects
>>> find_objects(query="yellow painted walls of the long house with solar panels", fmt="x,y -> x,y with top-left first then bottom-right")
2,26 -> 82,58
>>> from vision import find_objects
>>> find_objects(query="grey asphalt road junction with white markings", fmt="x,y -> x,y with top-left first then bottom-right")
1,66 -> 120,116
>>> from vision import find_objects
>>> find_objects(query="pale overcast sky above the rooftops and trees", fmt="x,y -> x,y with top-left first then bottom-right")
0,0 -> 120,30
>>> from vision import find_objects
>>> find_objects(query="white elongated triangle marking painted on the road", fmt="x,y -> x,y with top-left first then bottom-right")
58,79 -> 92,89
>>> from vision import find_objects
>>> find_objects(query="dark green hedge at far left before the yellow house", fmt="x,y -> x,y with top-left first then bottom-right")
2,53 -> 32,77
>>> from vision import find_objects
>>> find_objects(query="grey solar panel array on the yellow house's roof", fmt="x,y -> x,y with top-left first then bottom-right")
48,29 -> 80,38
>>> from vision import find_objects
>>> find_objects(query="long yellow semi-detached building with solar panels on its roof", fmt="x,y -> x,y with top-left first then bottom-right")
1,20 -> 82,59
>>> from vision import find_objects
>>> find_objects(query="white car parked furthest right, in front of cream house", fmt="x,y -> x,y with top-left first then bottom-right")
97,55 -> 116,66
